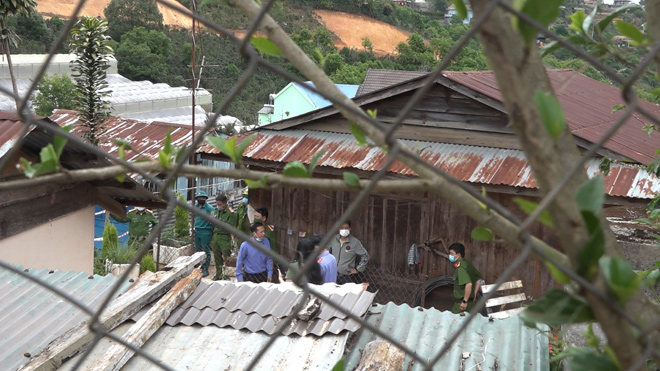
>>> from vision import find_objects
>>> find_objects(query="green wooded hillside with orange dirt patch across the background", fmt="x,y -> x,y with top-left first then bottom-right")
8,0 -> 656,123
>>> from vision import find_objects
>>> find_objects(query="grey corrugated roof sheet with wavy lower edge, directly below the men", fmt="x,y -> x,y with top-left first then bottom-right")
133,281 -> 375,336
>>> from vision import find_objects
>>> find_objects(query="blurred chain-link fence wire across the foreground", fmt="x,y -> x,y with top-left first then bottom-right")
0,0 -> 660,370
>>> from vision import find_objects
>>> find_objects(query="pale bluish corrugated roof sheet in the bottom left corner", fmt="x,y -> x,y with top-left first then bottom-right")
0,267 -> 130,370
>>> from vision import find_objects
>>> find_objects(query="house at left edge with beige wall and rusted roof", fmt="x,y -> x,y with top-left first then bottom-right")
0,112 -> 164,273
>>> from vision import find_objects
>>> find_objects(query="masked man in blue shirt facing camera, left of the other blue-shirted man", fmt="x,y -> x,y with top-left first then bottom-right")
236,223 -> 273,283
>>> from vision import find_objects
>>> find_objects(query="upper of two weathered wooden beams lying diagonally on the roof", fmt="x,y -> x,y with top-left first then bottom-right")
19,252 -> 206,370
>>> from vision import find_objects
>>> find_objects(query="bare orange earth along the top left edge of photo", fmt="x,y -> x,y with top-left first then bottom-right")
37,0 -> 192,28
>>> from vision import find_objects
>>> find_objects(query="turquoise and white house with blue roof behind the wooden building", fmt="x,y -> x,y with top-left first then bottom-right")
258,81 -> 358,125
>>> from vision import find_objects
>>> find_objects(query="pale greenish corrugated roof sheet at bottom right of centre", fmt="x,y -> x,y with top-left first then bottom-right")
346,303 -> 549,371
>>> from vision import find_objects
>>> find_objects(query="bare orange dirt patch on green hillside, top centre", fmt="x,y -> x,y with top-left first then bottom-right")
315,10 -> 410,55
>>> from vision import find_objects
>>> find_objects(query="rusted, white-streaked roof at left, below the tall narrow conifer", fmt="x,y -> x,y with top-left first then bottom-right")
50,110 -> 203,161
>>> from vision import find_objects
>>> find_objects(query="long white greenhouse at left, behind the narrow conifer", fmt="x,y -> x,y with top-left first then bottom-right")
0,54 -> 213,126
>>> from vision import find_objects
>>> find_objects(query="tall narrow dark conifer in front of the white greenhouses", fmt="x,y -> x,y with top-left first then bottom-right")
69,17 -> 113,145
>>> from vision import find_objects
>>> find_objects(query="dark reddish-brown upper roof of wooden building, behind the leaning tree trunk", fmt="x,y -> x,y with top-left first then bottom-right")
358,69 -> 660,165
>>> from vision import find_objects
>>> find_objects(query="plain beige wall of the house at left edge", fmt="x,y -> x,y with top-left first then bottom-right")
0,206 -> 94,274
